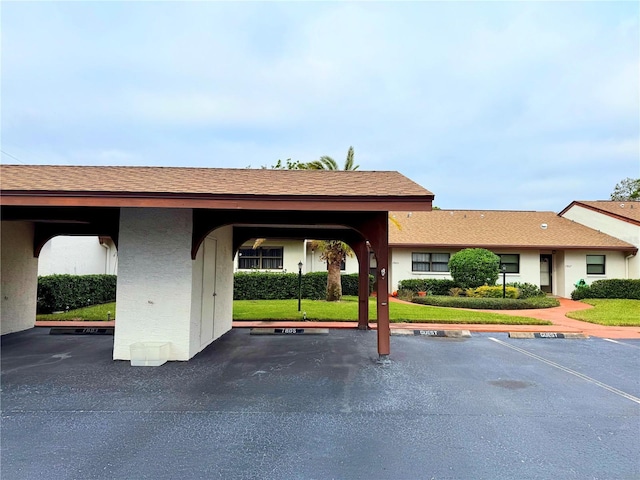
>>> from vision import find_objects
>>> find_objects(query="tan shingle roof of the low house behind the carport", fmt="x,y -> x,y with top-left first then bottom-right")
389,210 -> 635,251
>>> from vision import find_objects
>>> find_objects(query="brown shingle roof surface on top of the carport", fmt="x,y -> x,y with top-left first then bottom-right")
0,165 -> 433,199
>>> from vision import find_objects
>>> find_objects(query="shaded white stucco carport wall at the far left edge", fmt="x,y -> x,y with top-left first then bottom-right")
0,222 -> 38,335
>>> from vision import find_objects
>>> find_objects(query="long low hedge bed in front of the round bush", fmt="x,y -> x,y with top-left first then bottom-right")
412,295 -> 560,310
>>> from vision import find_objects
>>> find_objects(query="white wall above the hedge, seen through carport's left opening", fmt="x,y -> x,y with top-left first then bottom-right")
38,235 -> 118,275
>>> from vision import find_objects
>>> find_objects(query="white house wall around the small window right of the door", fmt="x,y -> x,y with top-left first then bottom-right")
558,250 -> 625,297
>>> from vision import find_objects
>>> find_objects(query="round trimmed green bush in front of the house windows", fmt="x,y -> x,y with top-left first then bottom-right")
449,248 -> 500,288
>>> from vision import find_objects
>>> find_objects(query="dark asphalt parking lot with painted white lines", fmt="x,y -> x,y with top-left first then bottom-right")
0,328 -> 640,480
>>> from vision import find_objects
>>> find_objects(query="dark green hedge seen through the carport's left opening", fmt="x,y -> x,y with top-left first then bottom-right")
37,275 -> 117,313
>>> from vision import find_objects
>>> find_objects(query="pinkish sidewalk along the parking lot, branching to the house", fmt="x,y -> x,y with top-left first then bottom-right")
35,297 -> 640,339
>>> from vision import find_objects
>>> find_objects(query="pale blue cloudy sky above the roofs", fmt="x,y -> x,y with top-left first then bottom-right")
0,0 -> 640,212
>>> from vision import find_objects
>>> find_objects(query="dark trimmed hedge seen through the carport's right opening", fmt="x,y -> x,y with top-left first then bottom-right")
233,272 -> 374,300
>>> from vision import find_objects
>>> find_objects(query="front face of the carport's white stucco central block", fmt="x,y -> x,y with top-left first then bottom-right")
113,208 -> 194,360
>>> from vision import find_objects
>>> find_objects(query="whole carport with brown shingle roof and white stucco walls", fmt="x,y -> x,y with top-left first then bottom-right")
0,165 -> 433,360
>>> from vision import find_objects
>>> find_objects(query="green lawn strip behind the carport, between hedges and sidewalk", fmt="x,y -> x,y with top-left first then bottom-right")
36,296 -> 550,325
